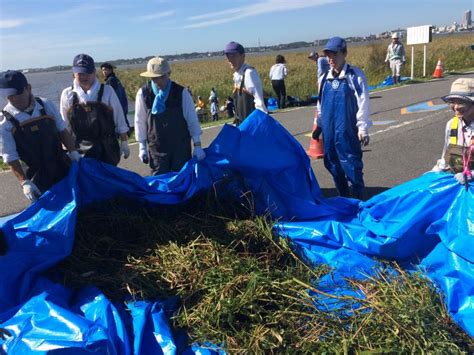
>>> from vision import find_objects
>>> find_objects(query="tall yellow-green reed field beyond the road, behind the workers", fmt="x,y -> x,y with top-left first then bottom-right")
118,34 -> 474,103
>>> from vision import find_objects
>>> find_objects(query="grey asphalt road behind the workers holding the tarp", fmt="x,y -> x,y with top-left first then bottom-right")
0,73 -> 474,216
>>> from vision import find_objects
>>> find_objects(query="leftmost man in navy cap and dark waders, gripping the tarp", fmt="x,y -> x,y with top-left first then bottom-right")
0,70 -> 81,202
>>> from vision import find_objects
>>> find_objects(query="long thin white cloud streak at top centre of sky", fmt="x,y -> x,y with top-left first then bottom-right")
182,0 -> 342,29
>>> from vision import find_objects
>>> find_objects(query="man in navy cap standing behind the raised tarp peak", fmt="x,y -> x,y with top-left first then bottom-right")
224,42 -> 268,126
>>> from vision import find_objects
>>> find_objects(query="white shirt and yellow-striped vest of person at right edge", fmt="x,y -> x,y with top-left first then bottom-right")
432,116 -> 474,173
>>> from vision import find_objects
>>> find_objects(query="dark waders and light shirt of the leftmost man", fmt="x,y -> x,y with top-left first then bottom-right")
0,97 -> 70,192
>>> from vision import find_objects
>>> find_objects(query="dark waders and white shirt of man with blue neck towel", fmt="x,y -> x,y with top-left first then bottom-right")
135,81 -> 202,175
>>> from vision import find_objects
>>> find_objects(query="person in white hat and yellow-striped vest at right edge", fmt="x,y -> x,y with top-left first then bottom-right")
433,78 -> 474,186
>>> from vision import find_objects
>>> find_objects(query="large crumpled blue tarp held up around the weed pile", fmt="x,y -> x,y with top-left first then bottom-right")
0,110 -> 474,354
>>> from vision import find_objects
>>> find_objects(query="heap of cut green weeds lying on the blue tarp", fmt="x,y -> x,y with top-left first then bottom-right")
50,197 -> 472,353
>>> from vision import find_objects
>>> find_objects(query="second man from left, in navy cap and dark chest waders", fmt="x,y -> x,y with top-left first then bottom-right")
60,54 -> 130,165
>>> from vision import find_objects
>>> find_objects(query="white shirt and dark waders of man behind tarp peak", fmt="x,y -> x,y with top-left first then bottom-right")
233,63 -> 267,125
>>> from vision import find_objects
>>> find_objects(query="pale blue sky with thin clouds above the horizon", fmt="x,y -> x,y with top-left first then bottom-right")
0,0 -> 474,71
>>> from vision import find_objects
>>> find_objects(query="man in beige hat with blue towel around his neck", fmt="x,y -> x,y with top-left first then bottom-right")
135,57 -> 206,175
